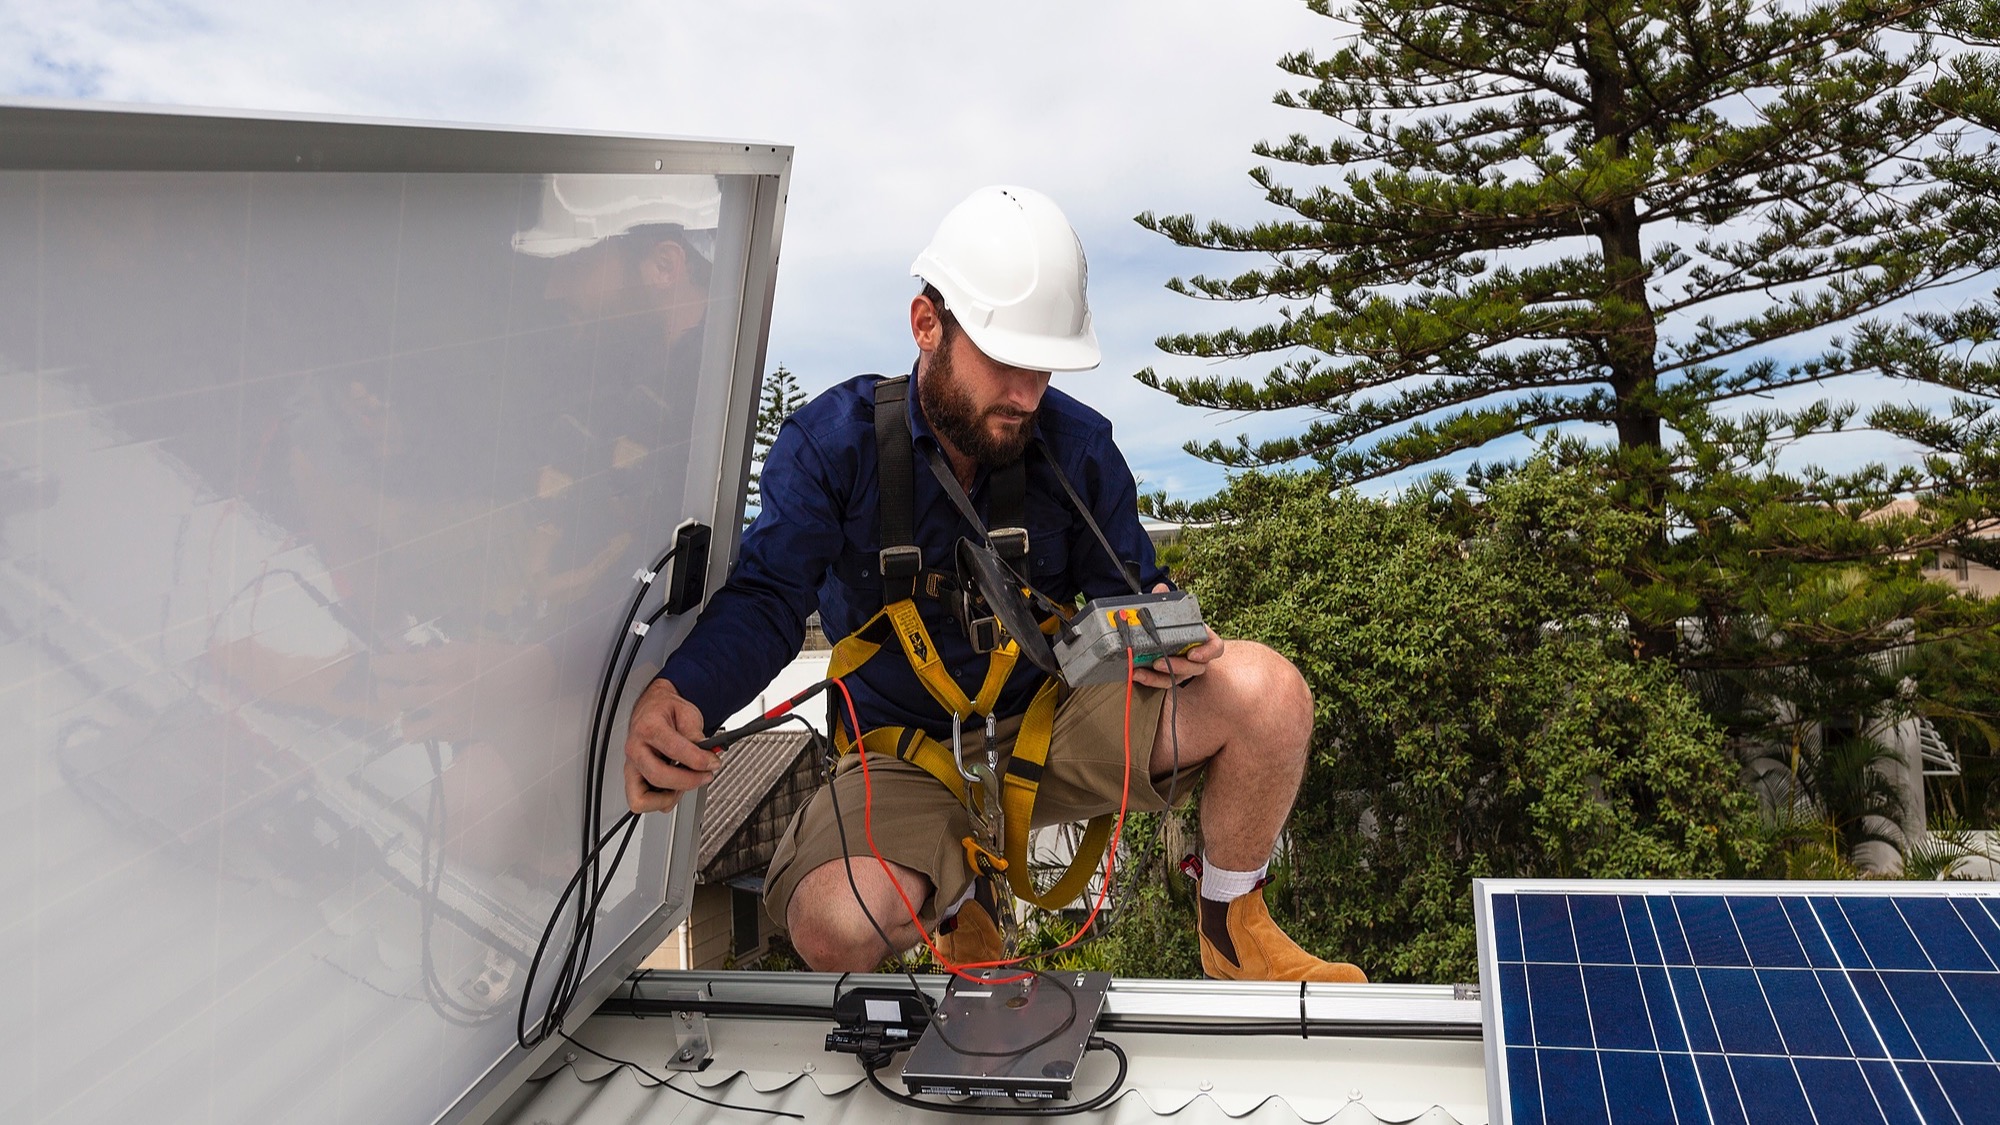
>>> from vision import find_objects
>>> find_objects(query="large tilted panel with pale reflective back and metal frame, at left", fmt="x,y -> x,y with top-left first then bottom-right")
0,104 -> 790,1123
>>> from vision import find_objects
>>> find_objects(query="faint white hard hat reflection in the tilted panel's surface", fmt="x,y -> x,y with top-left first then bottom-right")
514,172 -> 722,258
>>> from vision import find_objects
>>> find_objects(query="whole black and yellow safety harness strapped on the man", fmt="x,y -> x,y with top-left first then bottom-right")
828,376 -> 1138,911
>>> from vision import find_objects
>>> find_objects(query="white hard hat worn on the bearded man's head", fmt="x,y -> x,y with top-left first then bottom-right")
910,186 -> 1102,370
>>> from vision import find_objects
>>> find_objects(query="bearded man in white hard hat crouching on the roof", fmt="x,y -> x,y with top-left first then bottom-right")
626,188 -> 1366,981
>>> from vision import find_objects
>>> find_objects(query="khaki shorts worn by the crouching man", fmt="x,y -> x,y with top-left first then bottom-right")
764,681 -> 1198,929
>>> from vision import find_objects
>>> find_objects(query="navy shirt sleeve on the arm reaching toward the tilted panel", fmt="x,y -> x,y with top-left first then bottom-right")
660,422 -> 846,729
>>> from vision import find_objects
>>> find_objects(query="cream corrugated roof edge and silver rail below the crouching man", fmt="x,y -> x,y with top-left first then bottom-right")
484,973 -> 1486,1125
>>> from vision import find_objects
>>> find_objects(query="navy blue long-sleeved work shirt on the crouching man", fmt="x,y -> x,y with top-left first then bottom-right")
660,374 -> 1166,739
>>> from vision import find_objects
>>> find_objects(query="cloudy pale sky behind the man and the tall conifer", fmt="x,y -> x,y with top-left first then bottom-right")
0,0 -> 1984,498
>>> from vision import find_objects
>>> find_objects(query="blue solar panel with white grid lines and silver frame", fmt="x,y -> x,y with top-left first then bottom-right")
1474,879 -> 2000,1125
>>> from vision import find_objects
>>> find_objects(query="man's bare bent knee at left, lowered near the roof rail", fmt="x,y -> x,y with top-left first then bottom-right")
784,855 -> 930,973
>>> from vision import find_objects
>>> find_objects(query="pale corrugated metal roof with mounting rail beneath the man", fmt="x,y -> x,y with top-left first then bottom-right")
480,975 -> 1486,1125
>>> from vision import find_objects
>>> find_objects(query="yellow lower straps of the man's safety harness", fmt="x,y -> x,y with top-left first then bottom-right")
826,599 -> 1116,911
